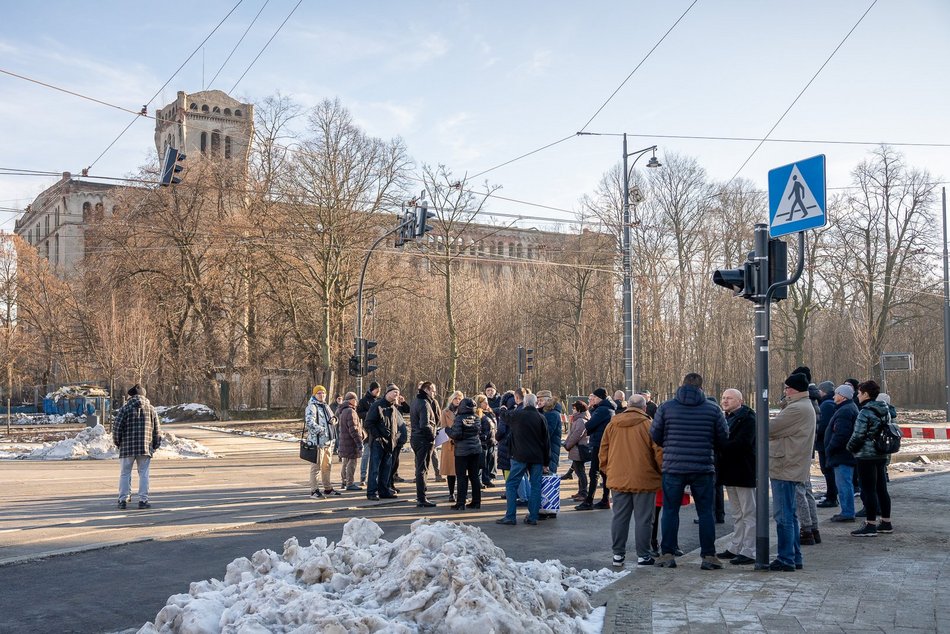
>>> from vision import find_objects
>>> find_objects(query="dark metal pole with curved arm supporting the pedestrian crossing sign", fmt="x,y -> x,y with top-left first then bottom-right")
752,224 -> 805,570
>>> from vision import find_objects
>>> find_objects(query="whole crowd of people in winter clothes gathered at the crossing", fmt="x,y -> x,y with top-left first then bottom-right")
303,366 -> 896,571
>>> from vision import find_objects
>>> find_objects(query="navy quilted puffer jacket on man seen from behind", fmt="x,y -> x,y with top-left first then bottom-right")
656,385 -> 729,474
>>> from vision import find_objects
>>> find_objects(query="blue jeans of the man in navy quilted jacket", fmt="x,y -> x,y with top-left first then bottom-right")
660,473 -> 716,557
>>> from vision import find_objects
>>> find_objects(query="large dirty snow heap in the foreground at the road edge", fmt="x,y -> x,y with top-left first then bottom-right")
139,518 -> 624,634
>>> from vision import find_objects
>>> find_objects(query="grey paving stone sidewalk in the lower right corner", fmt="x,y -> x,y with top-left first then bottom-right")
593,473 -> 950,634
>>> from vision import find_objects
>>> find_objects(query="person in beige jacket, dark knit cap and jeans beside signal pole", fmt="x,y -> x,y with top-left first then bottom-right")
769,373 -> 815,572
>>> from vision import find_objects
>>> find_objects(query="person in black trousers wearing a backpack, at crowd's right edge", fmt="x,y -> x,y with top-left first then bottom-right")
848,381 -> 894,537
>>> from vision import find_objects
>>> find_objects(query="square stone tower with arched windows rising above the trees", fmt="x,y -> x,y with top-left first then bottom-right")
155,90 -> 254,169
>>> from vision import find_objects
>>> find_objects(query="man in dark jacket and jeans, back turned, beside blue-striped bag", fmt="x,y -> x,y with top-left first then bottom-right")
496,394 -> 551,525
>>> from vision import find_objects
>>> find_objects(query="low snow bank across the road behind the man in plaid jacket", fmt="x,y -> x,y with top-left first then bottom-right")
0,425 -> 217,460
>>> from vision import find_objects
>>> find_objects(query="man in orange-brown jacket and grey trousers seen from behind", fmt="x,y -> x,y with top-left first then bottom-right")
599,394 -> 663,568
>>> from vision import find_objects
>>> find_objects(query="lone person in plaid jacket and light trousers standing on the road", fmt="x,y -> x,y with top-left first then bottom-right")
112,383 -> 162,509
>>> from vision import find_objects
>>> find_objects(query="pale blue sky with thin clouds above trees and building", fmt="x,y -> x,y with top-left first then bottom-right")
0,0 -> 950,231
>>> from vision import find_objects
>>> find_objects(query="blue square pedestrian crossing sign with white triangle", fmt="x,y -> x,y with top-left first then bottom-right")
769,154 -> 828,238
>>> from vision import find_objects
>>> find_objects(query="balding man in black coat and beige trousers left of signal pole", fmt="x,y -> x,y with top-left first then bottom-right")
716,388 -> 755,565
